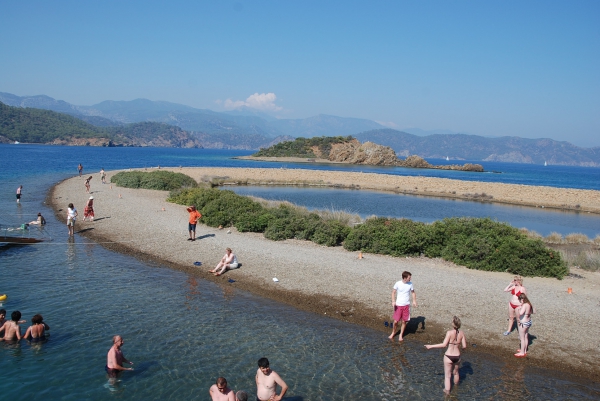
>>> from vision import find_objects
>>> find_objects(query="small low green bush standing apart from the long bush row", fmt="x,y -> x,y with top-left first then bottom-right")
110,170 -> 198,191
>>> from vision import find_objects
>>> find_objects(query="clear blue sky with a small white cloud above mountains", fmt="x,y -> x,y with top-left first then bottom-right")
0,0 -> 600,147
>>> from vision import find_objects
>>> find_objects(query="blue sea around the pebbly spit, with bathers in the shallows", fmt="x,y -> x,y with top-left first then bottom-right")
0,145 -> 600,401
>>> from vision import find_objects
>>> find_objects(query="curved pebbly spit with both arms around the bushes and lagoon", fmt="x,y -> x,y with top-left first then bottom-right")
48,168 -> 600,380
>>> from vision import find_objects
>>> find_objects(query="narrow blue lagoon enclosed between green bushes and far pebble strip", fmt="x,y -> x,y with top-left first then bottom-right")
227,186 -> 600,238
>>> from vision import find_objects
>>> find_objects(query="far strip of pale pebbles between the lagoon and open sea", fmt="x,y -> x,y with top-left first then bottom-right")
207,162 -> 600,214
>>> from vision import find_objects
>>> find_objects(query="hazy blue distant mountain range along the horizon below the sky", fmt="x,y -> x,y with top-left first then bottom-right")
0,92 -> 600,167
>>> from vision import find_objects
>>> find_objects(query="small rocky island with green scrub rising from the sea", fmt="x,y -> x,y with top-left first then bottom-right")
239,136 -> 483,172
